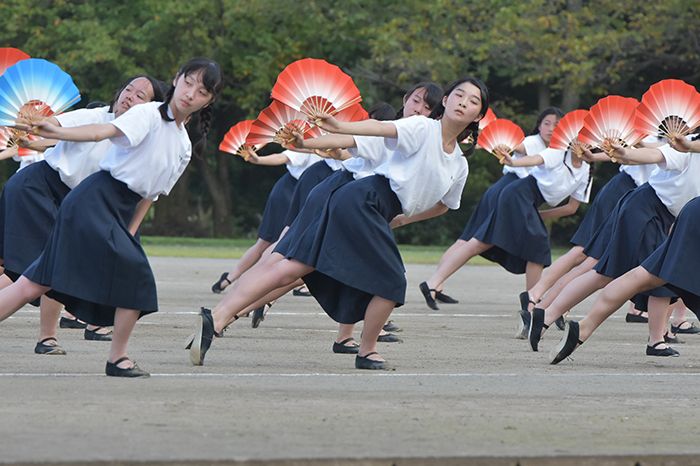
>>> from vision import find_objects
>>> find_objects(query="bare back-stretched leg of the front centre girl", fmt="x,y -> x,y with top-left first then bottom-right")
213,253 -> 313,332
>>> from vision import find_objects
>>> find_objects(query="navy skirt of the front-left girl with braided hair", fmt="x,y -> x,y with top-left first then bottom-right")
23,171 -> 158,326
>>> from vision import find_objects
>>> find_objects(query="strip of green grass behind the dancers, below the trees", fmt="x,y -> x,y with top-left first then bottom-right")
141,236 -> 566,265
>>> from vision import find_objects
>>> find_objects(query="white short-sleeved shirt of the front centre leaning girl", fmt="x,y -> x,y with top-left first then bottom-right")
370,115 -> 469,216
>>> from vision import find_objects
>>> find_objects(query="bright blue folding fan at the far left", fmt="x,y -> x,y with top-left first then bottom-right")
0,58 -> 80,126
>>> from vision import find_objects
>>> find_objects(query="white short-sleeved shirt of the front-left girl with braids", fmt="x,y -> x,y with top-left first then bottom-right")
100,102 -> 192,200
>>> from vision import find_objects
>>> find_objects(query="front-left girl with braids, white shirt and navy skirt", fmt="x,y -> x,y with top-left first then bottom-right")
0,58 -> 222,377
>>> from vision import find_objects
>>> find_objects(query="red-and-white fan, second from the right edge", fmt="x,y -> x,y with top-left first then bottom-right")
578,95 -> 643,159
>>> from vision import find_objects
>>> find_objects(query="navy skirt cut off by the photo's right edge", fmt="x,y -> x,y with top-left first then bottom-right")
642,197 -> 700,318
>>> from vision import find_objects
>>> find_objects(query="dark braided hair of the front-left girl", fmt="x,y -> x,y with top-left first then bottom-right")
158,57 -> 224,155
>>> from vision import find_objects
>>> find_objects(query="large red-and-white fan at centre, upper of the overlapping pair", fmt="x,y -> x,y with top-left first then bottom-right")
272,58 -> 362,118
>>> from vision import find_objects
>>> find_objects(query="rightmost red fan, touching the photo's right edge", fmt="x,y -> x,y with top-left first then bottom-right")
635,79 -> 700,139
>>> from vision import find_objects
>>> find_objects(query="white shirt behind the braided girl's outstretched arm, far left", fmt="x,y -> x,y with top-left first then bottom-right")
45,107 -> 114,189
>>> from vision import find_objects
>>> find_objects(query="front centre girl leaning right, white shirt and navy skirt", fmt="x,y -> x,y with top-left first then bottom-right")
190,78 -> 488,369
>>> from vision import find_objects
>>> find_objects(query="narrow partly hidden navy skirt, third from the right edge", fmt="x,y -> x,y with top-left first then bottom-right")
570,172 -> 637,247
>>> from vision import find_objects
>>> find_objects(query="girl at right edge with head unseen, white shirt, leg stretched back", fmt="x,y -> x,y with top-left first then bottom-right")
530,138 -> 700,356
